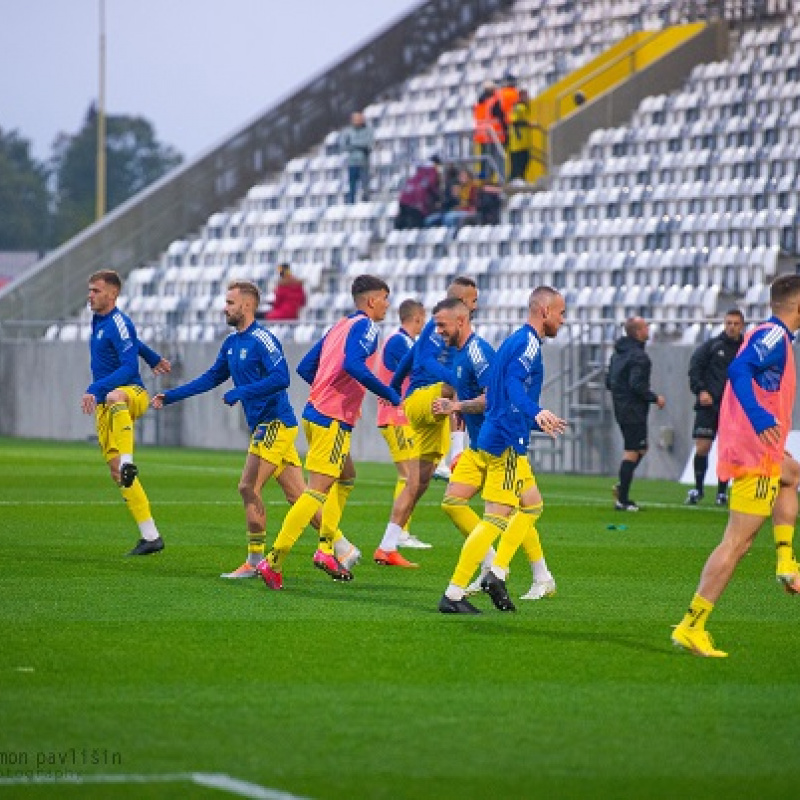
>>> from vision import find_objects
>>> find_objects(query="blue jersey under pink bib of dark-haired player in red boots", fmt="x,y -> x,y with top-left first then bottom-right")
297,311 -> 400,430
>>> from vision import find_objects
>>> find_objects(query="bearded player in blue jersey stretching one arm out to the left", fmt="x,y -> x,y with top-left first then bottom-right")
152,281 -> 354,579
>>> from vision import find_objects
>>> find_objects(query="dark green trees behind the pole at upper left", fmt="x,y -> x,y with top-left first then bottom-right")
0,105 -> 183,252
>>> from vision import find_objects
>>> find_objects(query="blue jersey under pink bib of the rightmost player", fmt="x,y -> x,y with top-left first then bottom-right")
728,317 -> 794,433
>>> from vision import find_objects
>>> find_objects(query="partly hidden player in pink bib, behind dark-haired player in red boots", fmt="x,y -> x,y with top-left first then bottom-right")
376,299 -> 430,549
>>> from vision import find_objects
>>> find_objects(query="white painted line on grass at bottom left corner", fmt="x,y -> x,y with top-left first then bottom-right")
0,772 -> 309,800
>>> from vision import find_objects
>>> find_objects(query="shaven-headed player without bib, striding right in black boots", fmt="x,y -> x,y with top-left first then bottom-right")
439,286 -> 567,614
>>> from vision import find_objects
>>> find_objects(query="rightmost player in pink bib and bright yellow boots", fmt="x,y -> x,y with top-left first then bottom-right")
672,275 -> 800,658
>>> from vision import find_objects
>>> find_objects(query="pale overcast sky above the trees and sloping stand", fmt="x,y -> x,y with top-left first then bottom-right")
0,0 -> 420,159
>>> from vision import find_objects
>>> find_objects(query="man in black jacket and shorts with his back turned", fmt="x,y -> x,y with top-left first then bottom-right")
606,317 -> 665,511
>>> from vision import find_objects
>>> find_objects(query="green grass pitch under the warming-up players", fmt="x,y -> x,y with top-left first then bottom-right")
0,439 -> 800,800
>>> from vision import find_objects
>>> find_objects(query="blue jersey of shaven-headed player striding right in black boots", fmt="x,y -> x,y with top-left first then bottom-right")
478,325 -> 544,456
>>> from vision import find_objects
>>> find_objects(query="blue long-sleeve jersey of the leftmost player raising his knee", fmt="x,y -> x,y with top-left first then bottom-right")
86,308 -> 152,403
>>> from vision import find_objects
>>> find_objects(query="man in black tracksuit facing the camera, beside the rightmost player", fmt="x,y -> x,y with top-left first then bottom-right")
686,308 -> 744,506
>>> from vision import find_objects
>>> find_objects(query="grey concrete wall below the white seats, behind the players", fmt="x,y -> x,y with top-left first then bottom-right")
9,334 -> 798,479
